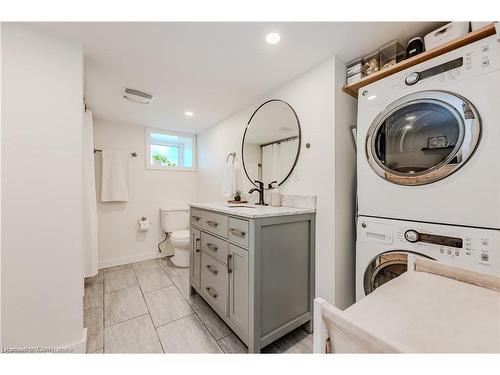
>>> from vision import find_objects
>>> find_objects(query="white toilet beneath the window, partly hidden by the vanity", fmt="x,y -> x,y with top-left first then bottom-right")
160,207 -> 189,267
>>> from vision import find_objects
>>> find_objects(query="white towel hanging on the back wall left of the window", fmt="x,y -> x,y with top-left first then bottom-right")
101,150 -> 130,202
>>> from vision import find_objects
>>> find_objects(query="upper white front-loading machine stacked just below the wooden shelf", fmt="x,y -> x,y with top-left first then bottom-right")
357,36 -> 500,229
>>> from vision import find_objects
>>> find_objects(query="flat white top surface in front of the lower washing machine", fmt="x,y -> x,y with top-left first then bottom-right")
342,270 -> 500,353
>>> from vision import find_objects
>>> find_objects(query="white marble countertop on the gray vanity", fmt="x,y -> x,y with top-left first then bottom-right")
190,202 -> 316,219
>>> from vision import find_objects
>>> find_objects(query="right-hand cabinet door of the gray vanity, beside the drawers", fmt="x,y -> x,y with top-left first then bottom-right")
228,245 -> 248,335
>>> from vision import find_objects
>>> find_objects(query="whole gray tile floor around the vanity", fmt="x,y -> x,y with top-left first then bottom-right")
83,258 -> 312,353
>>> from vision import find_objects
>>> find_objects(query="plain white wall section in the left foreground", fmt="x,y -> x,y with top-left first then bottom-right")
1,23 -> 83,347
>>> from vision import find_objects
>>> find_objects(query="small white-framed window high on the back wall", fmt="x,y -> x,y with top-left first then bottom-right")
146,129 -> 196,171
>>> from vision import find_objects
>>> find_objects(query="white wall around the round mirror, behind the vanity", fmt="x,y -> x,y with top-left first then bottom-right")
197,58 -> 355,304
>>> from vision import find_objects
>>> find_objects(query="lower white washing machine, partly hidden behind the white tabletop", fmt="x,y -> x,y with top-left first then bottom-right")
356,216 -> 500,301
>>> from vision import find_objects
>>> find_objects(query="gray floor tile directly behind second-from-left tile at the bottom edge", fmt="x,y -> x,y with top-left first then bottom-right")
104,286 -> 148,327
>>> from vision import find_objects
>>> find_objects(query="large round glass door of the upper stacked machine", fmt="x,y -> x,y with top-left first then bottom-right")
366,91 -> 481,185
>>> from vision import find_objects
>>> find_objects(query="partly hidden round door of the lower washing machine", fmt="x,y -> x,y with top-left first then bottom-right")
363,250 -> 431,295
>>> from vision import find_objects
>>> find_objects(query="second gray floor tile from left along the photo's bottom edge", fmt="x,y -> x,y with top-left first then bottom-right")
104,314 -> 163,353
